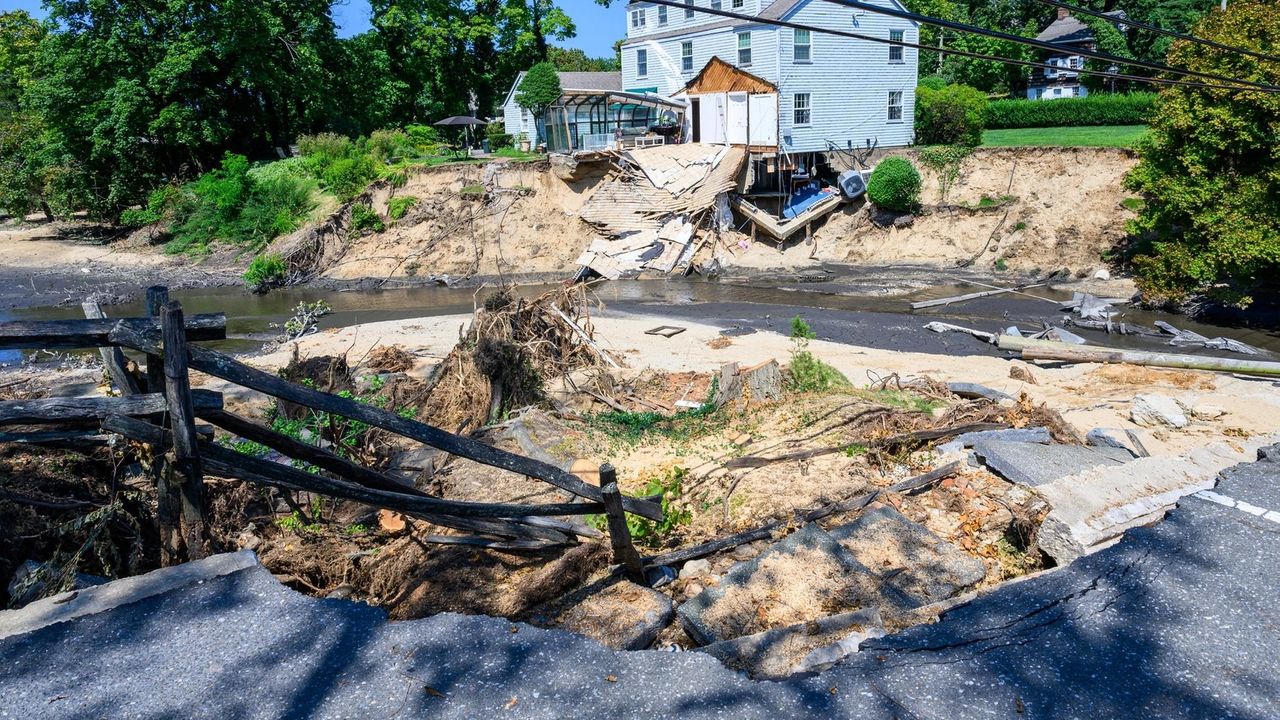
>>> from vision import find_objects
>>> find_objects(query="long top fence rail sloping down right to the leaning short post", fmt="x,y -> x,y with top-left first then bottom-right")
110,324 -> 663,520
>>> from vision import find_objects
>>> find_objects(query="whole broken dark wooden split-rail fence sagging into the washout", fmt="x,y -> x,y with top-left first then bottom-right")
0,287 -> 663,582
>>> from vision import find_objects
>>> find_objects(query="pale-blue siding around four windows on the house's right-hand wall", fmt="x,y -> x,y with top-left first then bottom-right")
764,0 -> 919,152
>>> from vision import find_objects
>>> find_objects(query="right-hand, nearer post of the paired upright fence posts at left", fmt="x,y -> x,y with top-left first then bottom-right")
161,302 -> 205,560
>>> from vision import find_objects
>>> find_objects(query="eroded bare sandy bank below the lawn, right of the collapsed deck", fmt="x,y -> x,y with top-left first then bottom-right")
722,147 -> 1137,274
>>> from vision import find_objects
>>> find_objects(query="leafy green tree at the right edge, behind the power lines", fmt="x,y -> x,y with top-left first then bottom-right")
1125,0 -> 1280,305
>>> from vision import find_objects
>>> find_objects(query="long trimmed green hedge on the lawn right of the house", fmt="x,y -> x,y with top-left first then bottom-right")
987,92 -> 1156,129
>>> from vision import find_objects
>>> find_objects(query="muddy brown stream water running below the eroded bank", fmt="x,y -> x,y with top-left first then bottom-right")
0,275 -> 1280,364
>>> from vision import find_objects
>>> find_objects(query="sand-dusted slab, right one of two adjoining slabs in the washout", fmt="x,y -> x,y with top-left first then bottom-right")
831,505 -> 987,606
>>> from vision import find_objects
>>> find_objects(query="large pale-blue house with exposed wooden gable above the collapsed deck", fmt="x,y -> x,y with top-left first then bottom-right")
622,0 -> 919,158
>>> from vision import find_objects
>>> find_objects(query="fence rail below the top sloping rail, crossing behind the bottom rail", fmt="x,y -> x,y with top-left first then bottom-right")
198,410 -> 576,541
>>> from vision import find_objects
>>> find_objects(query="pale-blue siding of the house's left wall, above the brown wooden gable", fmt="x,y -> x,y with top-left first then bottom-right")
622,23 -> 778,95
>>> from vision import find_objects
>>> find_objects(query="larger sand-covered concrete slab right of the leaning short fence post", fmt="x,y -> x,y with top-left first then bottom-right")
677,524 -> 916,644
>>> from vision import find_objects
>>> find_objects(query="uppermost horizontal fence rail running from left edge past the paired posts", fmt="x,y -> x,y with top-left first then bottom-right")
0,313 -> 227,350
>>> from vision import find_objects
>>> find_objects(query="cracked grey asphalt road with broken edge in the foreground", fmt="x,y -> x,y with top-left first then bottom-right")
0,448 -> 1280,720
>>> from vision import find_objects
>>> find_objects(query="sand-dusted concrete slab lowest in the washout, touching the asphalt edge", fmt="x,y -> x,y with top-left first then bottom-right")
698,610 -> 884,680
